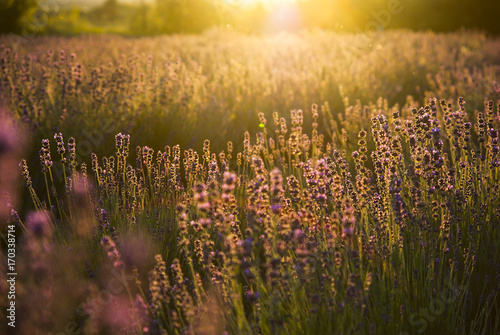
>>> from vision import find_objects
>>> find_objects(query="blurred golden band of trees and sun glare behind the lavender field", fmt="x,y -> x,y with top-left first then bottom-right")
0,0 -> 500,36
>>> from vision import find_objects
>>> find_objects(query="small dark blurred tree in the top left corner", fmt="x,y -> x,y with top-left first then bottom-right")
0,0 -> 38,34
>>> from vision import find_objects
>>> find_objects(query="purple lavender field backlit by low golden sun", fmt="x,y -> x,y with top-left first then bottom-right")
0,29 -> 500,335
